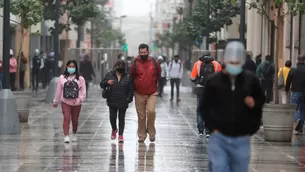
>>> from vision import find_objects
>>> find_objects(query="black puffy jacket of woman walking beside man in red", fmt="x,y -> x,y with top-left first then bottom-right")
100,71 -> 134,109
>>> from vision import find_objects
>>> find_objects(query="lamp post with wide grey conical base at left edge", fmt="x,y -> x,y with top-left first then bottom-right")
0,0 -> 21,134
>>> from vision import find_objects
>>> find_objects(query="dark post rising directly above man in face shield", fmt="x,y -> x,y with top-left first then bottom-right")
239,0 -> 246,46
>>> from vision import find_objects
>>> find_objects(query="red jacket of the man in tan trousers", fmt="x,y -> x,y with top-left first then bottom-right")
130,57 -> 161,95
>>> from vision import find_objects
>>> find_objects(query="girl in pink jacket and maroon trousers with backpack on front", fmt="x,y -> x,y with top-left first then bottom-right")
53,60 -> 86,143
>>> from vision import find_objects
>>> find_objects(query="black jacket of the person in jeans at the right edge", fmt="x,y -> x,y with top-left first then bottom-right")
285,63 -> 305,92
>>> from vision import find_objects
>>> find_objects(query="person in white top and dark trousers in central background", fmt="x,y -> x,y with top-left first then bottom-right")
167,55 -> 183,102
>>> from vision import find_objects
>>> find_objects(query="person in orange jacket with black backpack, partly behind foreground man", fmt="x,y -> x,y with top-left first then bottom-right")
190,52 -> 221,139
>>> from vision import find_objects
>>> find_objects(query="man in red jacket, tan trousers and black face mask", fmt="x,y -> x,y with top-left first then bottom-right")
130,44 -> 161,142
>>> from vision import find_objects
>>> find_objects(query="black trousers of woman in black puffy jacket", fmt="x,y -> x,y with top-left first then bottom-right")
109,107 -> 126,135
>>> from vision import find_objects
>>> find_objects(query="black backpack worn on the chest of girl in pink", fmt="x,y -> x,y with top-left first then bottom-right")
63,78 -> 79,99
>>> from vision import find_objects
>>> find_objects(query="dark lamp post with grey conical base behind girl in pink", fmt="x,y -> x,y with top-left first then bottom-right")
45,0 -> 60,103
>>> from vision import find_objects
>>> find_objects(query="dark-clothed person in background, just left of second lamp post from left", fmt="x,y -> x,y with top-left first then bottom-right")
31,49 -> 44,94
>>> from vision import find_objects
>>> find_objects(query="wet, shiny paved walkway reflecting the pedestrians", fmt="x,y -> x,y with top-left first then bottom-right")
0,87 -> 305,172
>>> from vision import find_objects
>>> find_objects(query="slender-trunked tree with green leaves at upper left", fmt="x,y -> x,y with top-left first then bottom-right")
0,0 -> 43,88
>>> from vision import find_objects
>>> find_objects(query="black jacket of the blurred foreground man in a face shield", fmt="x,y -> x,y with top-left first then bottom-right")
199,71 -> 265,136
